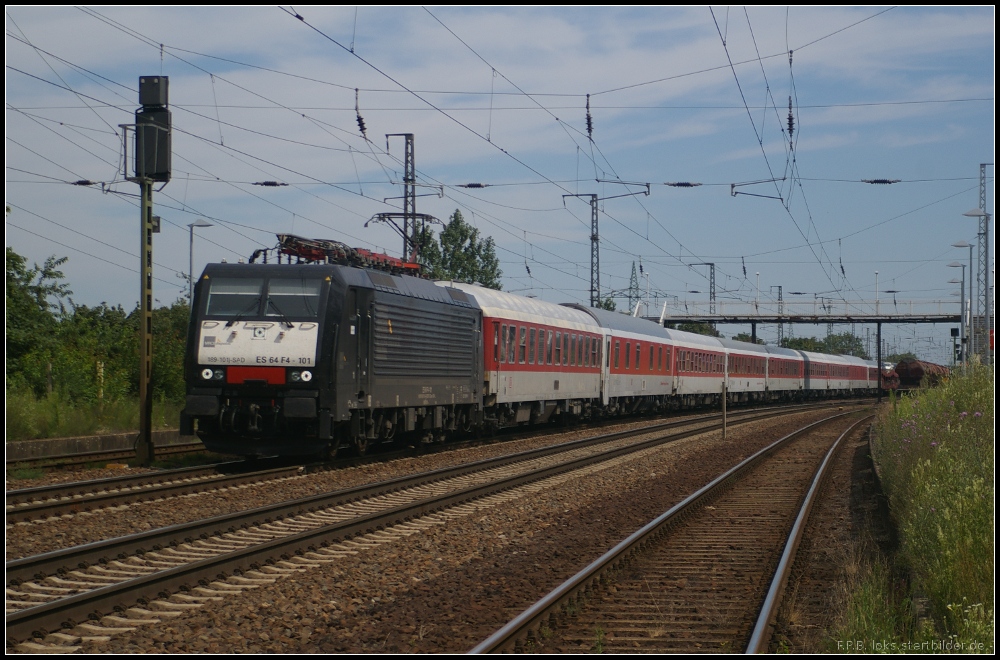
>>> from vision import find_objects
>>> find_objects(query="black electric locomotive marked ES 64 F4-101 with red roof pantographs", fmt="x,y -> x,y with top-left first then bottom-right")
181,235 -> 483,457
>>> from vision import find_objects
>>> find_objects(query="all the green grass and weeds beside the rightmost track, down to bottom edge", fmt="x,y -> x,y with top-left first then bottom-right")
831,366 -> 995,652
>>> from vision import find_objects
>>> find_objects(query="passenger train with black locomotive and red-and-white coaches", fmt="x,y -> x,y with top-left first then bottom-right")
180,234 -> 879,458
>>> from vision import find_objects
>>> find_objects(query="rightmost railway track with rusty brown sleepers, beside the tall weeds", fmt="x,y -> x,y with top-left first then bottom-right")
473,413 -> 864,653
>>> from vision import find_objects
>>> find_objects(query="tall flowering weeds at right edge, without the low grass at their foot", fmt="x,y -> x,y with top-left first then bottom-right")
873,365 -> 995,640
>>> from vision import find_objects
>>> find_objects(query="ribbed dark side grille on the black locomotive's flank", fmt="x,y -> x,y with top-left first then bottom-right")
373,298 -> 475,378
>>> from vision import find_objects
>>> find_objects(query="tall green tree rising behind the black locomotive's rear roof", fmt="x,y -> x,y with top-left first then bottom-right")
420,209 -> 503,290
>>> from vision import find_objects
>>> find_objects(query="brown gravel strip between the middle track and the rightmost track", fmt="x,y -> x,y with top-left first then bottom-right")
82,412 -> 829,653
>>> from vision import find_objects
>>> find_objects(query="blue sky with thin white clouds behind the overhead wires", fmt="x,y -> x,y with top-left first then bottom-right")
5,6 -> 995,362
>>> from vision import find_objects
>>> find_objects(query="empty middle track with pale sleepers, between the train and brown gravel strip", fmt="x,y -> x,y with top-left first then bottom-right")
6,404 -> 828,650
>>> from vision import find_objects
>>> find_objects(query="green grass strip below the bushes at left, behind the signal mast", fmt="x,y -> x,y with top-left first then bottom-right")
6,390 -> 183,442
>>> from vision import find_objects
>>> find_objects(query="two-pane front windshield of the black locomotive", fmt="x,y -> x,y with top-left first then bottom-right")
205,277 -> 322,318
